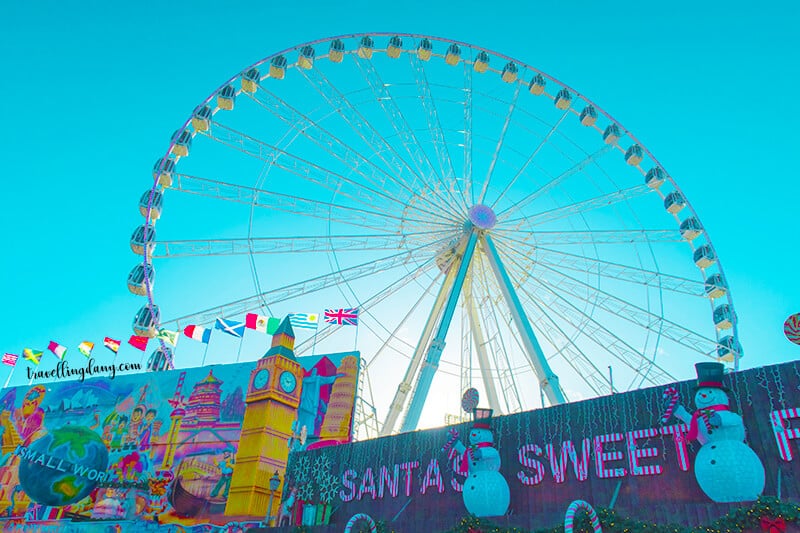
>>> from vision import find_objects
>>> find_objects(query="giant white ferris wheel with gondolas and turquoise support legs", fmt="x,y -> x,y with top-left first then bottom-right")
128,34 -> 742,434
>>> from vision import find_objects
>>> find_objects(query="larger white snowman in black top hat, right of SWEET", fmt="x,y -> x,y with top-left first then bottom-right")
675,363 -> 764,503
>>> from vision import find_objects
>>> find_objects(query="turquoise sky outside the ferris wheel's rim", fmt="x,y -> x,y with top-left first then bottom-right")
0,1 -> 800,394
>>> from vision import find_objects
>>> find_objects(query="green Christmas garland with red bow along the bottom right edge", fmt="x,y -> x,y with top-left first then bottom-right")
447,497 -> 800,533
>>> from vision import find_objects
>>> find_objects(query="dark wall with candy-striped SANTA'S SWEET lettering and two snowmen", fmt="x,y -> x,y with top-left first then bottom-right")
284,362 -> 800,531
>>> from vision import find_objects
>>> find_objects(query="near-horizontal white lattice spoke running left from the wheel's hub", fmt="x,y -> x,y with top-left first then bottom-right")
150,231 -> 444,259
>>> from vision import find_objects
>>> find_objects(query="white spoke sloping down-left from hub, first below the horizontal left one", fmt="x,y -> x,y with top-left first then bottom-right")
161,239 -> 445,326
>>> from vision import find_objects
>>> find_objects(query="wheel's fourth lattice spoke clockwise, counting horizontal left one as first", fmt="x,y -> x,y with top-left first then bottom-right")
246,84 -> 454,223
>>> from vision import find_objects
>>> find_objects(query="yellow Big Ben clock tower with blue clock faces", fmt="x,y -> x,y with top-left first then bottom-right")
225,318 -> 303,518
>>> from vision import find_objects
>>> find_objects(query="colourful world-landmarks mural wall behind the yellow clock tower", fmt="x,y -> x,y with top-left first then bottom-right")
0,352 -> 359,531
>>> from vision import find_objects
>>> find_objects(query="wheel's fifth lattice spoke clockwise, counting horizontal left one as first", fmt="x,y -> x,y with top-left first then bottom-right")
300,69 -> 459,218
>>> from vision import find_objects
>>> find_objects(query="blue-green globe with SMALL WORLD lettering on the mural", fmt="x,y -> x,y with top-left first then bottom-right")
19,425 -> 108,507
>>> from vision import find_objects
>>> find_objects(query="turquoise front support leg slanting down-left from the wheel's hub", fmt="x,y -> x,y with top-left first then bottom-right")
401,229 -> 478,431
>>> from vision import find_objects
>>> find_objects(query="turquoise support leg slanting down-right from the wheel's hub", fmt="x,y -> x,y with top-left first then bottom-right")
482,234 -> 566,405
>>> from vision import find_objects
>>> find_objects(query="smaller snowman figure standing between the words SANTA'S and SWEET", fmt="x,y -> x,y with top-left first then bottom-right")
446,421 -> 510,517
